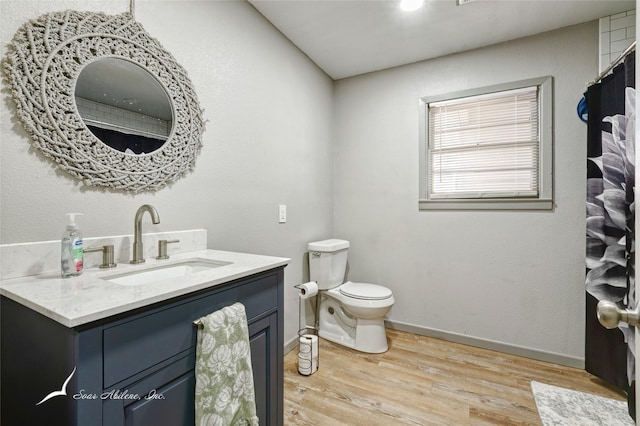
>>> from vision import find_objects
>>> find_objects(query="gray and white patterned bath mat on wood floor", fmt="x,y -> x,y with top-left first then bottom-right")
531,381 -> 635,426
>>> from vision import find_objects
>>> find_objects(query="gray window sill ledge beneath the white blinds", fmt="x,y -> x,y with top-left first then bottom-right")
418,198 -> 553,210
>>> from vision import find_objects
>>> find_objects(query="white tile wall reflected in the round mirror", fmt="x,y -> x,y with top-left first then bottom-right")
76,96 -> 171,138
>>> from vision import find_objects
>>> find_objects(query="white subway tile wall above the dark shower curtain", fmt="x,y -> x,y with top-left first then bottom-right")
600,10 -> 636,72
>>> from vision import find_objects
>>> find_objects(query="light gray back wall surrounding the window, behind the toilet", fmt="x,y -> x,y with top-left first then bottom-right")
334,22 -> 598,364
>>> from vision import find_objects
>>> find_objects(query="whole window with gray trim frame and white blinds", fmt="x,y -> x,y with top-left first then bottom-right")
419,77 -> 553,210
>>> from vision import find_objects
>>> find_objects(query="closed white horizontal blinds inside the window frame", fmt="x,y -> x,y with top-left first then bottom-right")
427,86 -> 540,199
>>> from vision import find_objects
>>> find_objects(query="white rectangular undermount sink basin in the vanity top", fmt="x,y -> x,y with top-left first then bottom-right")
101,259 -> 232,286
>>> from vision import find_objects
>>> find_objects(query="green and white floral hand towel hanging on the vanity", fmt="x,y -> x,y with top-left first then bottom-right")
195,303 -> 258,426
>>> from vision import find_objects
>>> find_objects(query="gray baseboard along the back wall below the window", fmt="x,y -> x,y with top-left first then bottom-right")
384,320 -> 584,370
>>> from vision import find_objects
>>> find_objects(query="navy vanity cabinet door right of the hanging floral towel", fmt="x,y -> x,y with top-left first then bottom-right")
249,313 -> 281,426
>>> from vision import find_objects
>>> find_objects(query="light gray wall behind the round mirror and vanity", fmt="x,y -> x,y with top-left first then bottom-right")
0,0 -> 333,339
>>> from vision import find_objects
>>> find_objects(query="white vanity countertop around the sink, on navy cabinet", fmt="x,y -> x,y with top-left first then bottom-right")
0,250 -> 291,327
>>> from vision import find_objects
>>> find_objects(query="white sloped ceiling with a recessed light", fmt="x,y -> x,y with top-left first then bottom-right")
248,0 -> 635,80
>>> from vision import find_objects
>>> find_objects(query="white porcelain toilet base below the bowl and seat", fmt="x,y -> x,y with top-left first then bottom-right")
318,298 -> 389,354
